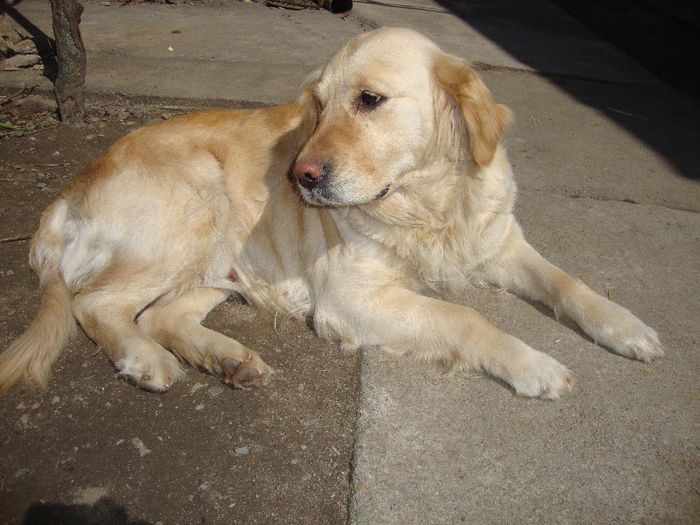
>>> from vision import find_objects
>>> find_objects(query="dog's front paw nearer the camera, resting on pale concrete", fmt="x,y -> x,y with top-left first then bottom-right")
509,347 -> 574,399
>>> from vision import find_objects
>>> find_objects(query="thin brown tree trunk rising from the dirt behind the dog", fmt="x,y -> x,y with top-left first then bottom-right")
51,0 -> 87,123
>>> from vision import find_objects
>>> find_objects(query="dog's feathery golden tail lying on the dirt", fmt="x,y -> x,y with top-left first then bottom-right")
0,199 -> 76,390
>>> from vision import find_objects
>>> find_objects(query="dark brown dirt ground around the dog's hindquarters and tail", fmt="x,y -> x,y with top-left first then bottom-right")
0,92 -> 359,524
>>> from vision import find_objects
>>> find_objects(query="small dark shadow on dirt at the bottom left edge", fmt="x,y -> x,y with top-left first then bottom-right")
22,498 -> 149,525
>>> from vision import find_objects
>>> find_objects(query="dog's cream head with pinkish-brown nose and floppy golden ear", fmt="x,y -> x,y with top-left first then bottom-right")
293,28 -> 510,206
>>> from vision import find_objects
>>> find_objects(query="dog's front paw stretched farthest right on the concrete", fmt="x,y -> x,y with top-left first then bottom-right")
590,303 -> 664,363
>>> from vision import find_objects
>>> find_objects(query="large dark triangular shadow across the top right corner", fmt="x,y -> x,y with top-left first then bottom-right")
437,0 -> 700,180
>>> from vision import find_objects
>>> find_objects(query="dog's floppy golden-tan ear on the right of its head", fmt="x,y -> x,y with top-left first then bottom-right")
435,53 -> 511,166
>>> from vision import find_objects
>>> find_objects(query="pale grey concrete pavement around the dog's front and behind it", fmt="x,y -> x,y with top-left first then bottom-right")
0,0 -> 700,524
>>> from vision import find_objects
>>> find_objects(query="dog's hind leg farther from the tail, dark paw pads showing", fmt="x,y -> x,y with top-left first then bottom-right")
138,288 -> 272,388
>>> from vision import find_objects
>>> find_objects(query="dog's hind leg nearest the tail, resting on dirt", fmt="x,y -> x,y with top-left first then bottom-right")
73,272 -> 183,392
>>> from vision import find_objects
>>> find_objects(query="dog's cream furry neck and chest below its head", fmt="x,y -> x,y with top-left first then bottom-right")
345,148 -> 516,284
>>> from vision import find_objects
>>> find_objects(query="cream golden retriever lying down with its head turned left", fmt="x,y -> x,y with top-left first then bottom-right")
0,28 -> 664,399
